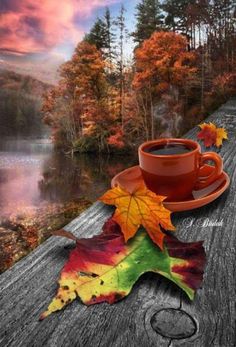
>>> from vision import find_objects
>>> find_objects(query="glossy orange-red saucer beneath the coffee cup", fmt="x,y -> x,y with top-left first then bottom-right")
111,165 -> 230,212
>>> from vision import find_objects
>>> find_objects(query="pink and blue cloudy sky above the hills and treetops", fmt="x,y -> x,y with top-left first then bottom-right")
0,0 -> 138,82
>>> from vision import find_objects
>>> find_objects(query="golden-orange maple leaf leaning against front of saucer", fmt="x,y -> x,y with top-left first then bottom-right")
99,184 -> 175,249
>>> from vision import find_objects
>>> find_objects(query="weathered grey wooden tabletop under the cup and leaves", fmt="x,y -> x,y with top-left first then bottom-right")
0,99 -> 236,347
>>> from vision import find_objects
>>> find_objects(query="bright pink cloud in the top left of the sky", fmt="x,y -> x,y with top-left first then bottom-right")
0,0 -> 119,54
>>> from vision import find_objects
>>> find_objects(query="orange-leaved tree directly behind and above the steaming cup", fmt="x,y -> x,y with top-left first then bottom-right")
133,32 -> 197,138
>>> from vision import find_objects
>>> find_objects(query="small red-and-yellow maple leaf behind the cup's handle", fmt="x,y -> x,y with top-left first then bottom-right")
197,123 -> 228,147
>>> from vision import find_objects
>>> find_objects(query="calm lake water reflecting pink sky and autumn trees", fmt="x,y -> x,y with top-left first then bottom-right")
0,140 -> 137,217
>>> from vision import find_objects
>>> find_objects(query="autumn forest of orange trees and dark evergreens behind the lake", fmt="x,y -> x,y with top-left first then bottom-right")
42,0 -> 236,153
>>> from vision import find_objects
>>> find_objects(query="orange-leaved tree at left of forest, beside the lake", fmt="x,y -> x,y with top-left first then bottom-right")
43,41 -> 121,151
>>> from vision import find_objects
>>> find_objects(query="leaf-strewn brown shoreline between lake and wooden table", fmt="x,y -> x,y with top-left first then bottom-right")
0,198 -> 92,274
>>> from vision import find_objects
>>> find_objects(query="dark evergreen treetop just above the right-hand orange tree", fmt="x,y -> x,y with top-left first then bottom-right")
132,0 -> 164,45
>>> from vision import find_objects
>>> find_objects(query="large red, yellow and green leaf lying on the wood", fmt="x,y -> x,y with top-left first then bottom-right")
40,218 -> 205,319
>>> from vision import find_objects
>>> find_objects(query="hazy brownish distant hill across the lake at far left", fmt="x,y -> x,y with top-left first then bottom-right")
0,69 -> 51,137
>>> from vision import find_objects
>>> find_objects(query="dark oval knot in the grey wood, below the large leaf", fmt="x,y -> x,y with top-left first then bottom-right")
150,308 -> 197,339
